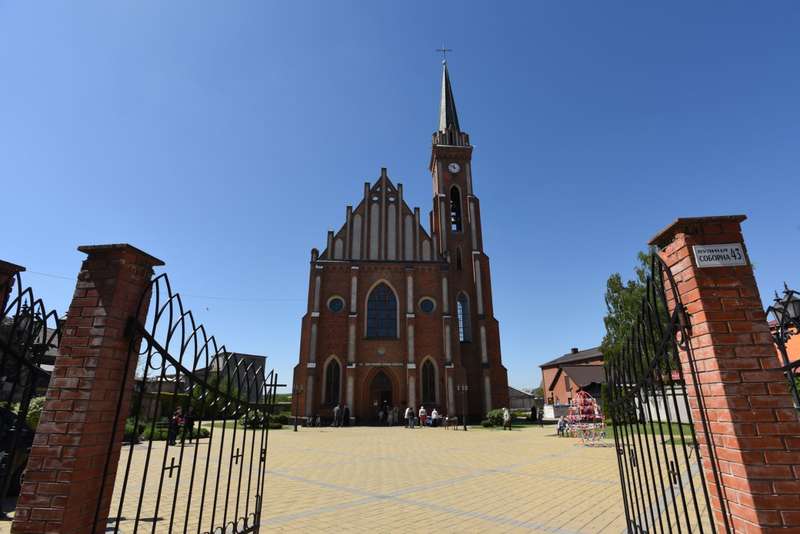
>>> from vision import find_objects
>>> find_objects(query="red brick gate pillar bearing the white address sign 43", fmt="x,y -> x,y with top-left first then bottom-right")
650,215 -> 800,533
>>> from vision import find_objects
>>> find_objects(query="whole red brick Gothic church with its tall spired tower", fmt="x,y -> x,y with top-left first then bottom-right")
293,62 -> 508,423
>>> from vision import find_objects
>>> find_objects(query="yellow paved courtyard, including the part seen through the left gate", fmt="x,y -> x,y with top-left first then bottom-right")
0,426 -> 625,534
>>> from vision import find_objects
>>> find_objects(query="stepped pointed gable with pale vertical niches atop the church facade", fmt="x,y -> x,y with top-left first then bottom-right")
320,169 -> 442,261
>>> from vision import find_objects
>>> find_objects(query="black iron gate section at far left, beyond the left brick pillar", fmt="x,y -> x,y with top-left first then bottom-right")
0,274 -> 60,519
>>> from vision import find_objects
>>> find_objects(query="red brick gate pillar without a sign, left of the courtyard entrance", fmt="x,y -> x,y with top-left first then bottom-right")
11,244 -> 163,534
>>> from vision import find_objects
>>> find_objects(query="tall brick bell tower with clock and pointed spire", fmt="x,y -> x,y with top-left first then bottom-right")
430,60 -> 508,418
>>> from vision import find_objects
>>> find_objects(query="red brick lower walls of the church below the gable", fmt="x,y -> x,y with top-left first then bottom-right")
293,261 -> 508,422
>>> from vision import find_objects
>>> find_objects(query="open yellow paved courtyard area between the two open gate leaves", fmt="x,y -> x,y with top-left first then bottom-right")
263,427 -> 625,534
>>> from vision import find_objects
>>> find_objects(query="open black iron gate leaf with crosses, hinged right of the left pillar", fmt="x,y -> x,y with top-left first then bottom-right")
94,274 -> 279,534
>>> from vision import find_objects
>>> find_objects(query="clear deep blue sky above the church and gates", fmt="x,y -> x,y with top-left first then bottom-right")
0,0 -> 800,392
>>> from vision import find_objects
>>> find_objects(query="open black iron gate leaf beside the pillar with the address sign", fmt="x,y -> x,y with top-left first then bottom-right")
605,254 -> 730,533
